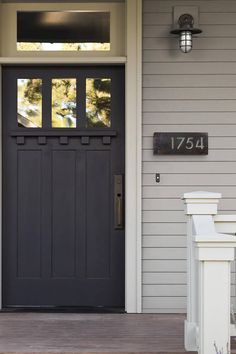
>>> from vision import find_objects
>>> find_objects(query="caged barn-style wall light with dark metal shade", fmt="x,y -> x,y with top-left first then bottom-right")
170,14 -> 202,53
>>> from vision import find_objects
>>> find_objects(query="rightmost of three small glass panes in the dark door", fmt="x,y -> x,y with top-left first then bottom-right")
86,78 -> 111,128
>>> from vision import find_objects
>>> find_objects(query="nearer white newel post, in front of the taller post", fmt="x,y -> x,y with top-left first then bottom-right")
196,237 -> 234,354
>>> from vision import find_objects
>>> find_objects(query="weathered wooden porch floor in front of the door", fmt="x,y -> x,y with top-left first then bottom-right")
0,313 -> 236,354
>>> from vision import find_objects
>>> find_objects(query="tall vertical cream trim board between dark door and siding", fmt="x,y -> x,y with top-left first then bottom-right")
125,0 -> 142,313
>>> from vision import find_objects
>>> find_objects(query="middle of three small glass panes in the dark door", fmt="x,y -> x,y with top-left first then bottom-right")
52,79 -> 76,128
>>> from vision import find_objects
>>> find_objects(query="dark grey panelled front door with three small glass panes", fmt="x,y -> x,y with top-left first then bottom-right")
3,66 -> 125,307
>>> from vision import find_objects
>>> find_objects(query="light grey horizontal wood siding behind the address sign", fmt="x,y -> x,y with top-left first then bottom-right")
142,0 -> 236,313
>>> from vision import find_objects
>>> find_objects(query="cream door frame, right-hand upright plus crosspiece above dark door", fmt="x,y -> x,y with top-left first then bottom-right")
0,0 -> 142,313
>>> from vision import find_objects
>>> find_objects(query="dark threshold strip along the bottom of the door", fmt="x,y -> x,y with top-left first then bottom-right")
0,306 -> 126,314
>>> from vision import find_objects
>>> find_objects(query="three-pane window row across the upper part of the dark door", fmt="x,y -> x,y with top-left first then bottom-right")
17,77 -> 112,128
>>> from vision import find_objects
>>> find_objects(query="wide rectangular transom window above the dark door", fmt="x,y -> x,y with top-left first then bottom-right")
17,11 -> 110,51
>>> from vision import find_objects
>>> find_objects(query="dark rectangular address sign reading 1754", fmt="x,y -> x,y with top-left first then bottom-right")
153,133 -> 208,155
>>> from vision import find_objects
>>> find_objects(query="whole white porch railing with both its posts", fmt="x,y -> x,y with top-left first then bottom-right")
183,192 -> 236,354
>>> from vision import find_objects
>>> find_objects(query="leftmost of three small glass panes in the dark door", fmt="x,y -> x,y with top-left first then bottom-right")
17,79 -> 42,128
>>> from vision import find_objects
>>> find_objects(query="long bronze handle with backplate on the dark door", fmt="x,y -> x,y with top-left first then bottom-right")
114,175 -> 124,229
